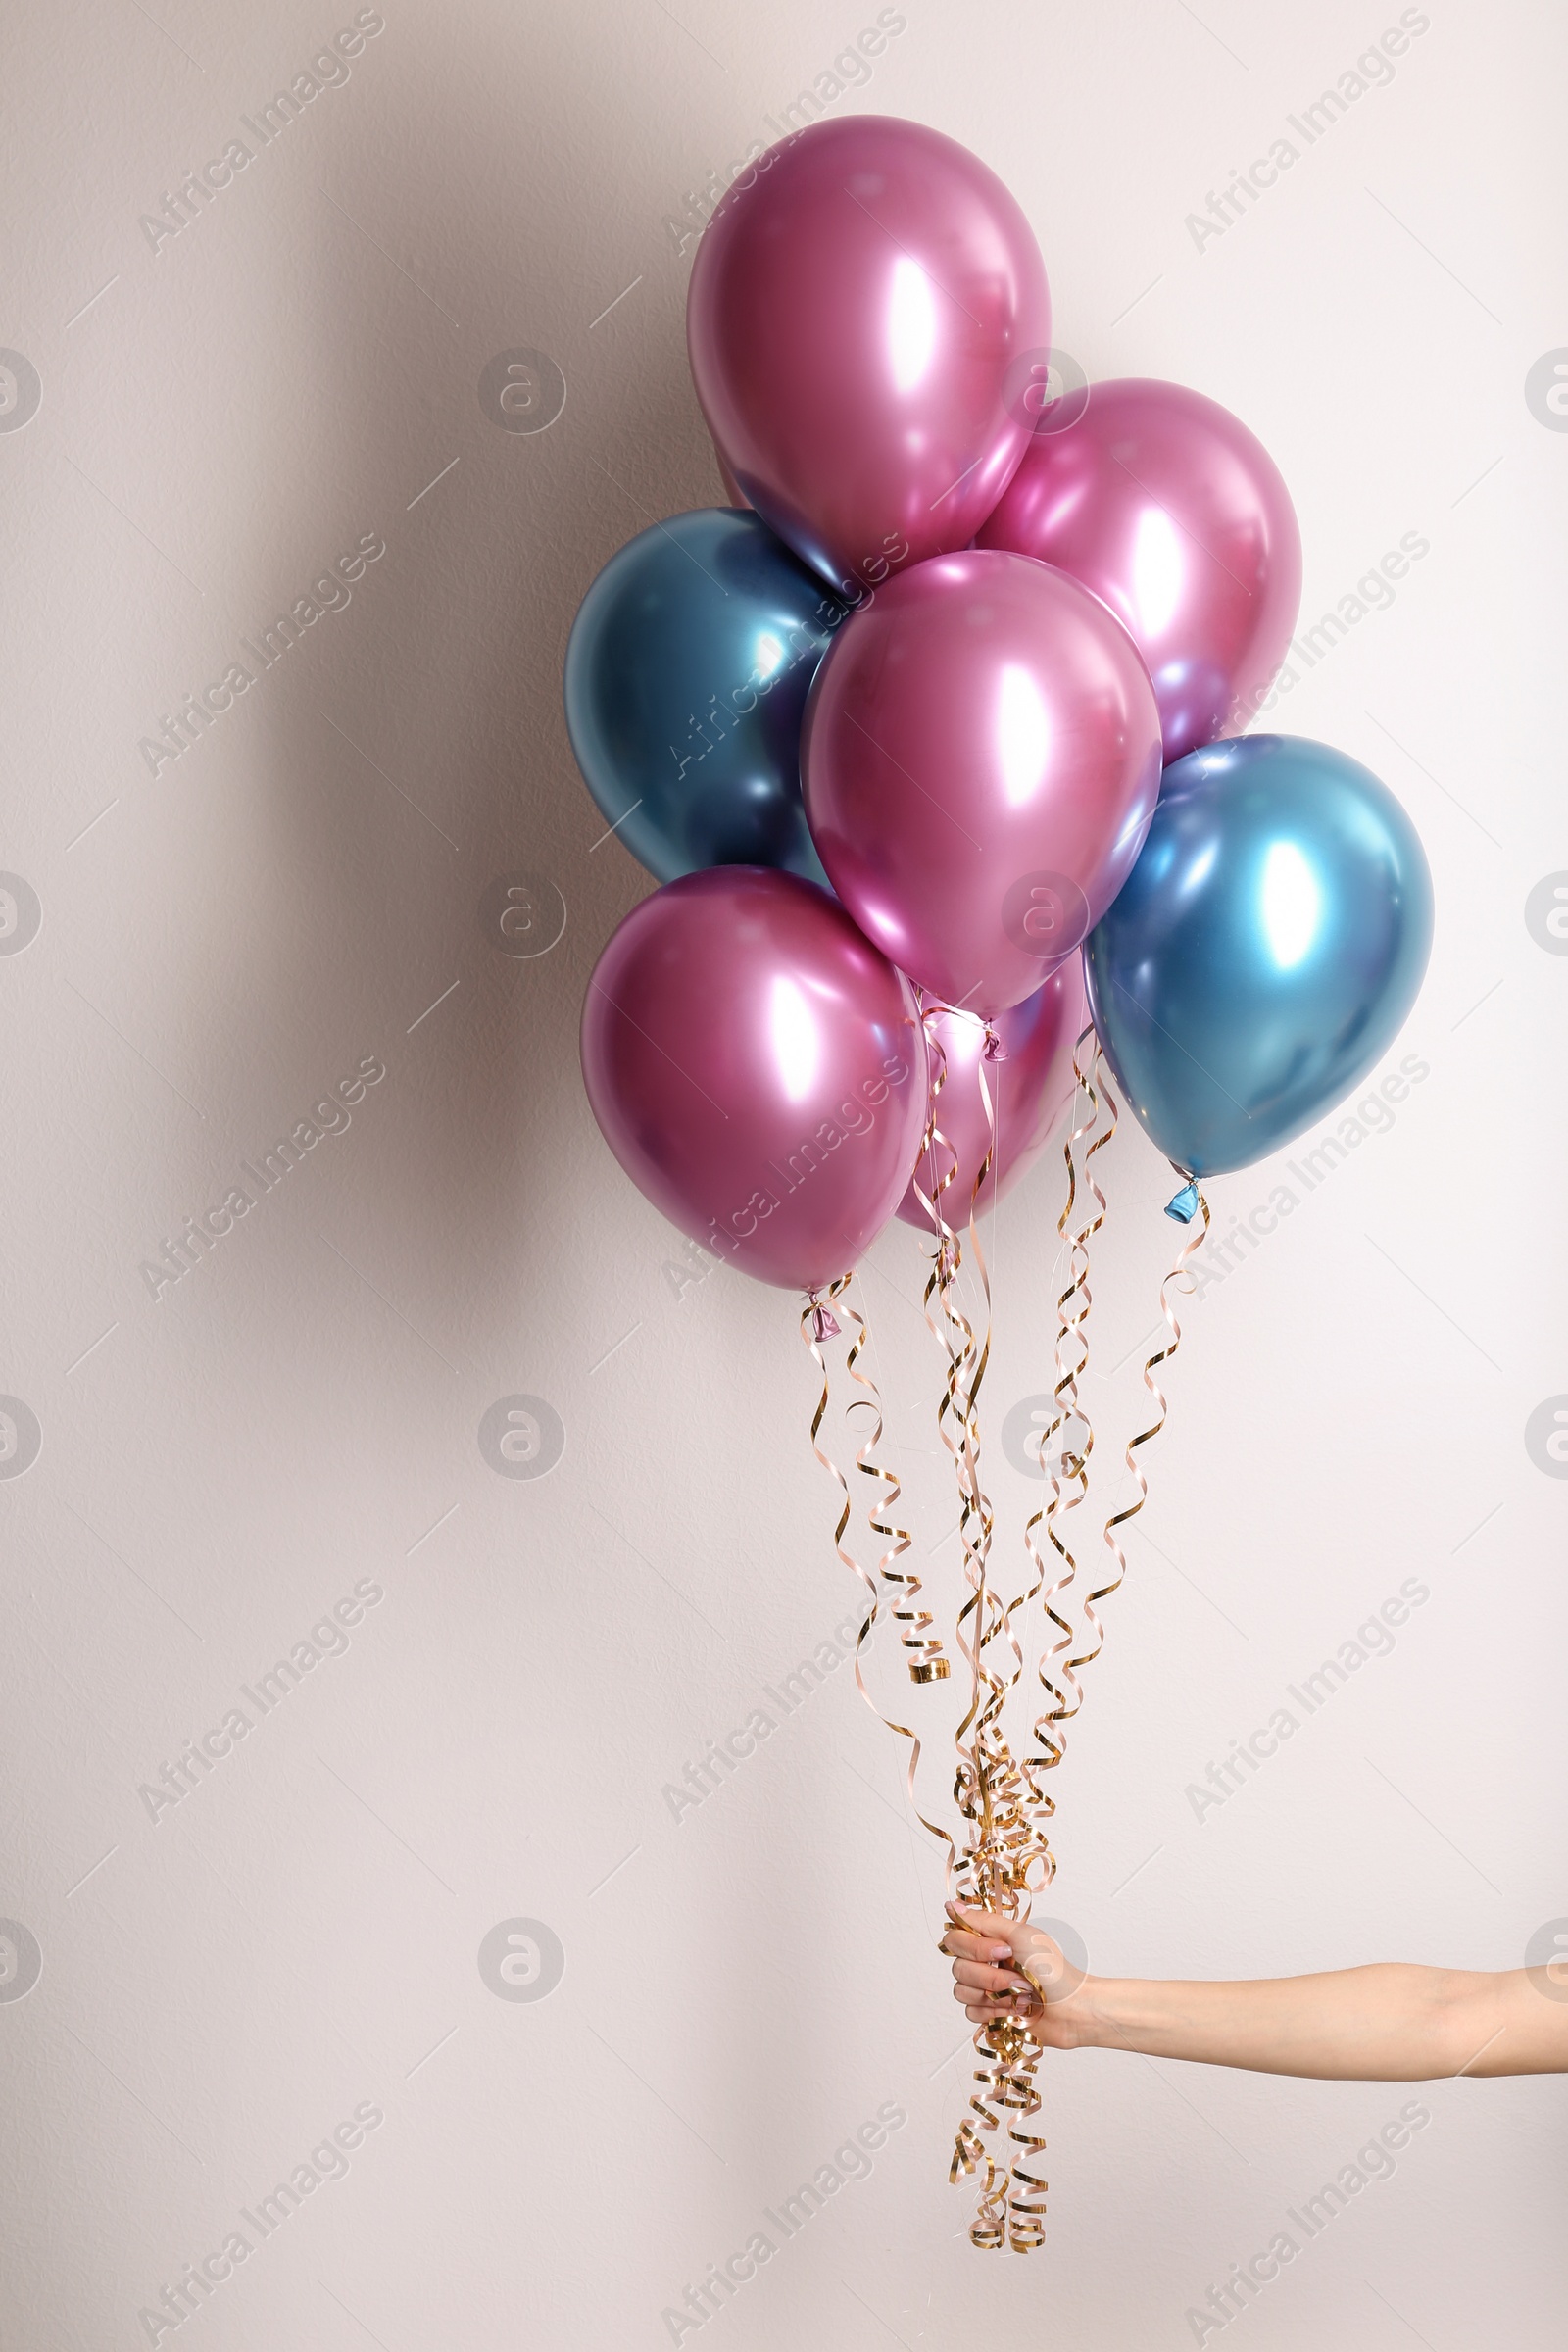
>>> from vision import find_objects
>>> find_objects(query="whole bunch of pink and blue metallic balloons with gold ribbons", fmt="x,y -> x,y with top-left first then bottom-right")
564,116 -> 1432,2246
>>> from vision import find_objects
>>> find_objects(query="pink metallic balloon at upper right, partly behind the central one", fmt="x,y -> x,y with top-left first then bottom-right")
978,376 -> 1302,766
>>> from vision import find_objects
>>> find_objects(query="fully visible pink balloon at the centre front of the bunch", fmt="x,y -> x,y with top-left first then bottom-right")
802,548 -> 1159,1018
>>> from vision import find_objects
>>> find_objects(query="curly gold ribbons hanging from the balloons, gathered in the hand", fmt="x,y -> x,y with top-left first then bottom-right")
802,1000 -> 1208,2253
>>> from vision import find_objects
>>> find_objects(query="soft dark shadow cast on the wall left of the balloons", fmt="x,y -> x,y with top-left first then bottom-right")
214,17 -> 733,1357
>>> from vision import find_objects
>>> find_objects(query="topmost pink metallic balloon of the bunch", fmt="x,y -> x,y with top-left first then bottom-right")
686,116 -> 1051,593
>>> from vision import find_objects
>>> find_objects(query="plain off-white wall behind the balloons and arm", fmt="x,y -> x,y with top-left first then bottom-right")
0,0 -> 1568,2352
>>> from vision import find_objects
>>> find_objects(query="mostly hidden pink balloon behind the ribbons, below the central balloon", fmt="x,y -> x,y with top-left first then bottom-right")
898,955 -> 1089,1233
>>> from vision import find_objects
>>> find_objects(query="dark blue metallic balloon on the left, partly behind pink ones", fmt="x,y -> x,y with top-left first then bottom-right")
566,506 -> 847,882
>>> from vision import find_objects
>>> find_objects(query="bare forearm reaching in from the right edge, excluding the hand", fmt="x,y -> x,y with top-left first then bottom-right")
1054,1962 -> 1568,2082
